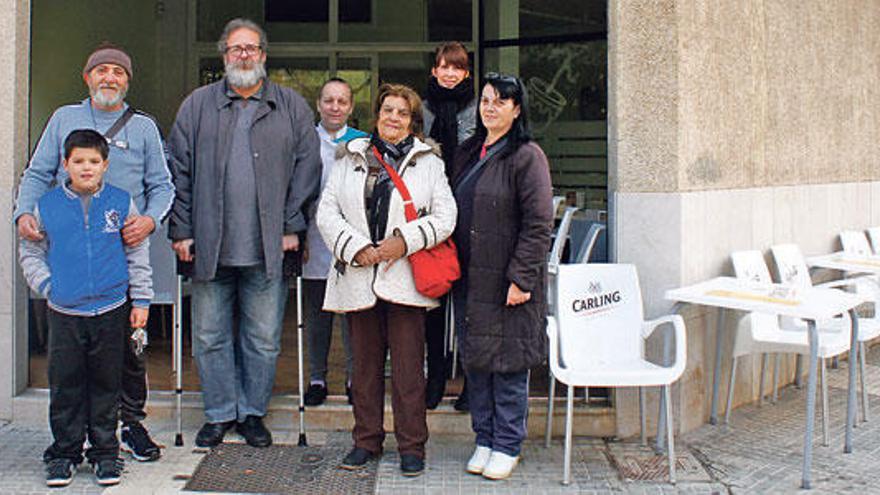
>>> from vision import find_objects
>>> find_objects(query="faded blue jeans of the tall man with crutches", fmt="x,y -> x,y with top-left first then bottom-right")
192,265 -> 287,423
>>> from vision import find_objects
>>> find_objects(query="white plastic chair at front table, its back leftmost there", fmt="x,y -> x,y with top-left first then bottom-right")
724,251 -> 861,438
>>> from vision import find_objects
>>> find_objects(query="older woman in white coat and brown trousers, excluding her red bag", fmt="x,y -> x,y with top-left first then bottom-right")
317,84 -> 457,476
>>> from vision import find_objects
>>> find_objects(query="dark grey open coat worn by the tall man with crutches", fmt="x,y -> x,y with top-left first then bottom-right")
168,79 -> 321,281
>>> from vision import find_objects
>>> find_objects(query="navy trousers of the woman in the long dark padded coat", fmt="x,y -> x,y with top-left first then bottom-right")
465,369 -> 529,456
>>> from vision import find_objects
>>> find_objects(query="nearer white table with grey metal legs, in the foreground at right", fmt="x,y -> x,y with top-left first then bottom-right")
665,277 -> 865,488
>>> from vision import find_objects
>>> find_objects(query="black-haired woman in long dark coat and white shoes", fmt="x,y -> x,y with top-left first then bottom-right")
452,74 -> 553,479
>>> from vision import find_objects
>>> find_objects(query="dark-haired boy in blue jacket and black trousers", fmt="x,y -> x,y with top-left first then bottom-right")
19,129 -> 153,486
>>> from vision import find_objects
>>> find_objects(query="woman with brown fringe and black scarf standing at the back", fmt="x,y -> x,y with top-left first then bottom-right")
424,41 -> 477,411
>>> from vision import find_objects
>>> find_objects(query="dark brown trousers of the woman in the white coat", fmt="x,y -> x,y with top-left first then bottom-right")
349,301 -> 428,458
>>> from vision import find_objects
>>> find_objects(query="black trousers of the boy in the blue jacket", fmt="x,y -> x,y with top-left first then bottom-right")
43,304 -> 130,463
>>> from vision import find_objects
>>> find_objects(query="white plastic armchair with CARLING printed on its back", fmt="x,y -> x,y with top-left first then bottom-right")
547,263 -> 687,485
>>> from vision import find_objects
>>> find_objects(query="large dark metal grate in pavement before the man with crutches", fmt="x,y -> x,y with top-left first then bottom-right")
184,443 -> 378,495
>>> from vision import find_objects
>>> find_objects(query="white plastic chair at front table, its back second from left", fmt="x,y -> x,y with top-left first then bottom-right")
770,244 -> 880,421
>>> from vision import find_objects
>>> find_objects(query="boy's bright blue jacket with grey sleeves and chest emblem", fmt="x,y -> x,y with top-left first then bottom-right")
19,182 -> 153,316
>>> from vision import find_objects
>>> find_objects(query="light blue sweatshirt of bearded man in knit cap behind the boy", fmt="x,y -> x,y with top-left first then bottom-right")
13,98 -> 174,227
